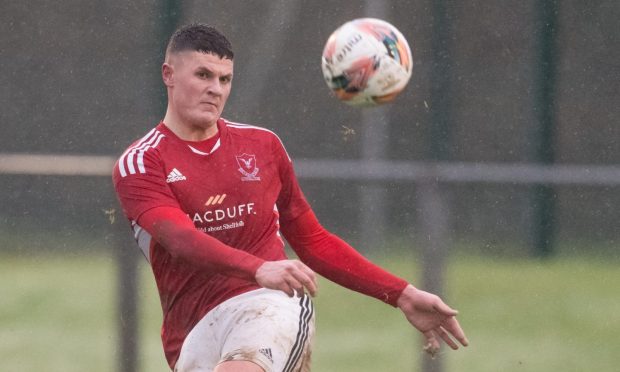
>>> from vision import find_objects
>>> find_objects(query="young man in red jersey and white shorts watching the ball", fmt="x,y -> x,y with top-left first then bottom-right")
113,24 -> 467,372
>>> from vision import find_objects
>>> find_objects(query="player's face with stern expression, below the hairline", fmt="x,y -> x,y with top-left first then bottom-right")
164,51 -> 233,129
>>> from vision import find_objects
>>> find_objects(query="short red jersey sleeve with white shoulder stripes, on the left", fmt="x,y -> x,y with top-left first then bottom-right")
112,145 -> 180,221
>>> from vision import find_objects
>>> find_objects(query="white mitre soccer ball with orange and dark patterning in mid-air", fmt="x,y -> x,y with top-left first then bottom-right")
321,18 -> 412,106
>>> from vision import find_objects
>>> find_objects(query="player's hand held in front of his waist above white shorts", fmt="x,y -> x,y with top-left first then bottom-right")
255,260 -> 317,297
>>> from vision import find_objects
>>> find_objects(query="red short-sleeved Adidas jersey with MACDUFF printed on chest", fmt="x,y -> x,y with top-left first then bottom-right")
113,119 -> 310,366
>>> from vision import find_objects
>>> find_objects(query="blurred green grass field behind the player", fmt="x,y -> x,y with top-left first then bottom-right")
0,253 -> 620,372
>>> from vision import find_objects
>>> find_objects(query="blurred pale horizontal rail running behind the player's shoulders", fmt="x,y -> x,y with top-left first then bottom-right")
0,154 -> 620,186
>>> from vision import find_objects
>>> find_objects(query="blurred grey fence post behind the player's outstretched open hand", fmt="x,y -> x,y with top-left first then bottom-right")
416,179 -> 449,372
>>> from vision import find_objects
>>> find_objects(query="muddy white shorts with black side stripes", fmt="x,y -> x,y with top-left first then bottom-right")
174,288 -> 314,372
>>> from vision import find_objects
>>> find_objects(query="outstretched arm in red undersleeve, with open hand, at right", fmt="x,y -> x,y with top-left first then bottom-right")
281,210 -> 468,355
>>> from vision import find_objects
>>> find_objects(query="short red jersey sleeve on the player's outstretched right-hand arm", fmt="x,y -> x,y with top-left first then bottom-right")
273,137 -> 310,221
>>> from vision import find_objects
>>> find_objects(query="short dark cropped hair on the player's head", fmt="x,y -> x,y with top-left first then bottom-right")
166,23 -> 234,60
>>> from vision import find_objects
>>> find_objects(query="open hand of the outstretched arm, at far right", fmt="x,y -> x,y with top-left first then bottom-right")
396,285 -> 469,357
